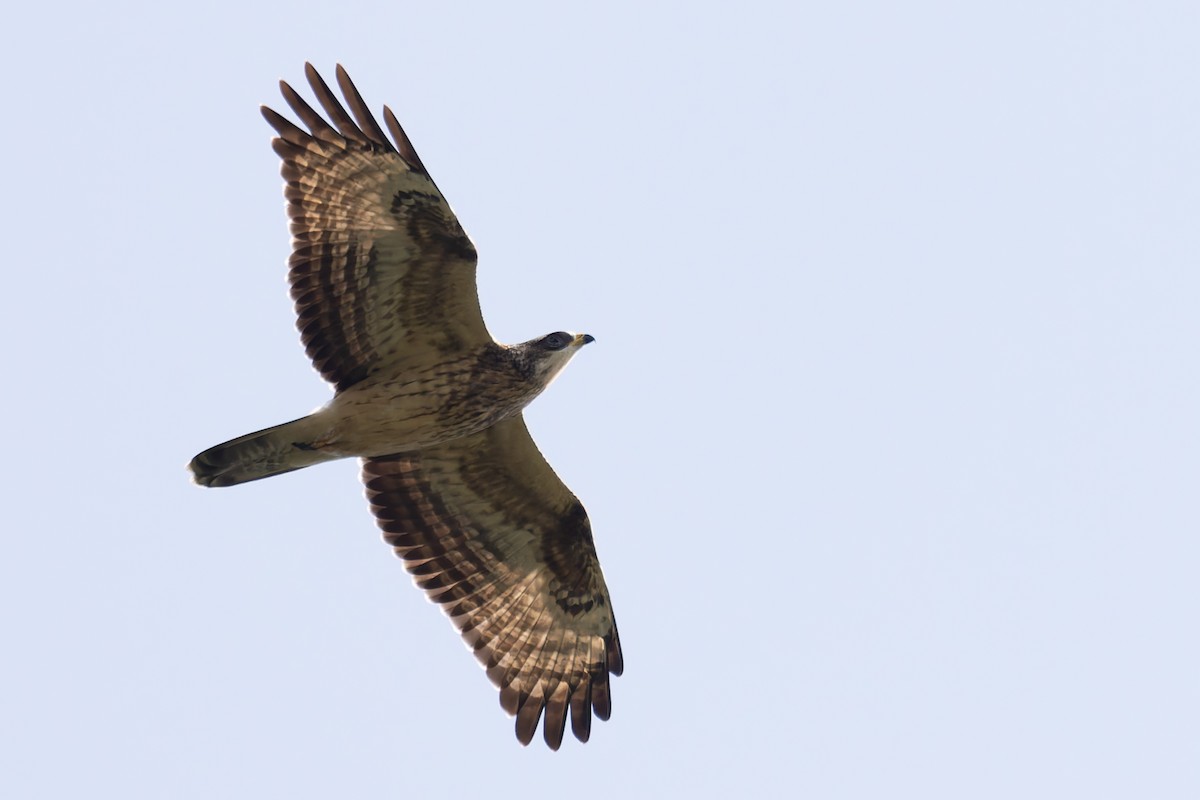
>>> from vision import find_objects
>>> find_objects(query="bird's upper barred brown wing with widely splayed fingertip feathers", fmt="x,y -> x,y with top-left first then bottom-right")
263,64 -> 491,390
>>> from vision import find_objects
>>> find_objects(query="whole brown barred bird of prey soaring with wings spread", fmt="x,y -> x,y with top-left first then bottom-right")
190,64 -> 623,750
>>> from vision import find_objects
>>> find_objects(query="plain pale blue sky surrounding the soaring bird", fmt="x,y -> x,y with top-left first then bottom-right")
0,0 -> 1200,800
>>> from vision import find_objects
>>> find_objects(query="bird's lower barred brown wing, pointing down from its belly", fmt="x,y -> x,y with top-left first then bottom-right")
362,415 -> 623,750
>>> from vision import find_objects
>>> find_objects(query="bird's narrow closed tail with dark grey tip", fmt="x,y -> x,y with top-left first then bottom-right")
187,416 -> 341,486
